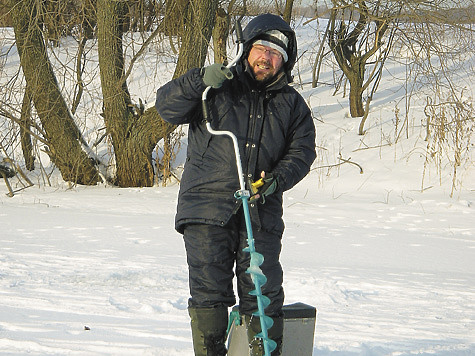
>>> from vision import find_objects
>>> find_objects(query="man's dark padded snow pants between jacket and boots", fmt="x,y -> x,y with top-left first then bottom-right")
184,210 -> 284,317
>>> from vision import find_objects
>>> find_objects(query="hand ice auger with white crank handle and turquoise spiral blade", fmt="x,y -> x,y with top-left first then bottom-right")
201,21 -> 277,356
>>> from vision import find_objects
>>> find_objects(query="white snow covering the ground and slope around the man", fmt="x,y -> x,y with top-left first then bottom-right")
0,18 -> 475,356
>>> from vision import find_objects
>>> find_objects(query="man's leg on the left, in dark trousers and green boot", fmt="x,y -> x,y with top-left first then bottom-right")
184,224 -> 237,356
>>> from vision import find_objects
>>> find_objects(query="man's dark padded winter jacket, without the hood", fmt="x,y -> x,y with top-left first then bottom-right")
155,16 -> 316,234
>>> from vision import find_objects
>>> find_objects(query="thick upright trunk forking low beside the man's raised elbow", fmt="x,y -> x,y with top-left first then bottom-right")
97,0 -> 173,187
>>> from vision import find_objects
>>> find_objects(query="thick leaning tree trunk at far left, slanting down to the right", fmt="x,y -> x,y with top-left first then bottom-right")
10,0 -> 101,184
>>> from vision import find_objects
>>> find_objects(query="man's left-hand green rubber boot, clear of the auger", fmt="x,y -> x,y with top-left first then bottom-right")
188,307 -> 228,356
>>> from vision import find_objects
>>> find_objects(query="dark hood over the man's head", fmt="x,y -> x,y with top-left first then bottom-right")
242,14 -> 297,83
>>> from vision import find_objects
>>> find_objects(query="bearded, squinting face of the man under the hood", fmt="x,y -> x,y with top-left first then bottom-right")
247,44 -> 284,81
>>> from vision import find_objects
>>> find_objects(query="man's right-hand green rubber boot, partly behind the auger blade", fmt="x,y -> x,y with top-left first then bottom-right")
244,315 -> 284,356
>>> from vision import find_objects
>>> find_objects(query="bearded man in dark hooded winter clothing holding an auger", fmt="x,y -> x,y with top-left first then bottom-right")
155,14 -> 315,356
